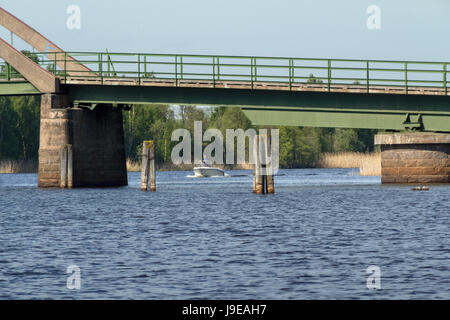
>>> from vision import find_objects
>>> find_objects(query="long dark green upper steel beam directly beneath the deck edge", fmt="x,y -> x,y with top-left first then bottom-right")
63,85 -> 450,115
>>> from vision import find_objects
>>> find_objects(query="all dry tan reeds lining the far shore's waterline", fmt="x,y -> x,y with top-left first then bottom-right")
0,152 -> 381,176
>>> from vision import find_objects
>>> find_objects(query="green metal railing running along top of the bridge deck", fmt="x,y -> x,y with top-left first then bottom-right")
0,52 -> 450,95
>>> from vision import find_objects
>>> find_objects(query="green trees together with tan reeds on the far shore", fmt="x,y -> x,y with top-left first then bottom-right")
0,91 -> 379,175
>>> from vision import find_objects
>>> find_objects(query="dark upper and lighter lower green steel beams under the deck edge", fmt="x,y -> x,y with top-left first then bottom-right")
67,85 -> 450,132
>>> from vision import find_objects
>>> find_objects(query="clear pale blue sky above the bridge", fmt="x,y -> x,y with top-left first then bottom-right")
0,0 -> 450,61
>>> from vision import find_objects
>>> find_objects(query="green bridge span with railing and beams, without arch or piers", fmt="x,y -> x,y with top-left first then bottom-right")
0,52 -> 450,132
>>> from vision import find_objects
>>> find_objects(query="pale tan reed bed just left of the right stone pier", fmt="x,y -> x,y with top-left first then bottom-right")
318,152 -> 381,176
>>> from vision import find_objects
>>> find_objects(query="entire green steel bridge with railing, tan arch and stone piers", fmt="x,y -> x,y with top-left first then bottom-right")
0,7 -> 450,188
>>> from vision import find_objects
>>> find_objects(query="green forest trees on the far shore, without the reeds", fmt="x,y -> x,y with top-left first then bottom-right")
0,96 -> 376,168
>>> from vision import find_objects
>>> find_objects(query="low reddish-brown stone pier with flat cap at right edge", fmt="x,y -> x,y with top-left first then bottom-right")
375,133 -> 450,184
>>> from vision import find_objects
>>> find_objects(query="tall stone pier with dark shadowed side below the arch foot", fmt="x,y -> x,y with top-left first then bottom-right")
38,94 -> 127,188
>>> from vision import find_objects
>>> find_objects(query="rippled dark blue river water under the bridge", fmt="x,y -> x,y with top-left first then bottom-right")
0,169 -> 450,299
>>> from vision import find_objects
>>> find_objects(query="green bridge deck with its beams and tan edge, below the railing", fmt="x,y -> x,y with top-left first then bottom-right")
0,77 -> 450,132
